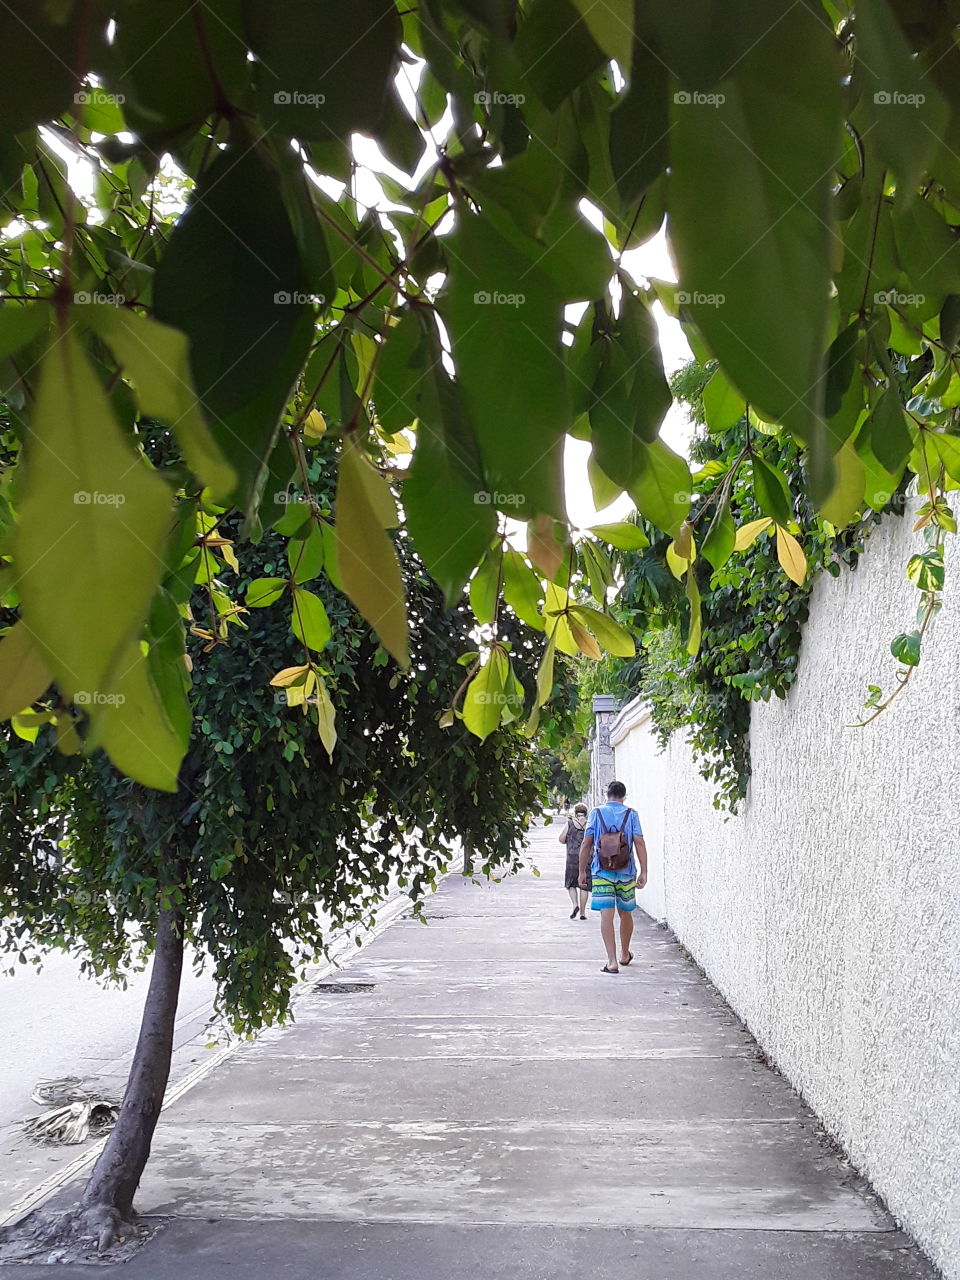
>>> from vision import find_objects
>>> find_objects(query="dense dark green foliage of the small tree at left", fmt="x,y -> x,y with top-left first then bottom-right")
0,442 -> 543,1029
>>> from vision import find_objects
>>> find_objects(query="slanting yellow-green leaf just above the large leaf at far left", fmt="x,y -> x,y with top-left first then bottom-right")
85,306 -> 237,499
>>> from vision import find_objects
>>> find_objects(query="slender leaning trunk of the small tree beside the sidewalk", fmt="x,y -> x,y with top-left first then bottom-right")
78,910 -> 183,1252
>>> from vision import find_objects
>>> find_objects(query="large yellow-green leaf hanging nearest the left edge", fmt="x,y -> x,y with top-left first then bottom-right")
15,323 -> 172,727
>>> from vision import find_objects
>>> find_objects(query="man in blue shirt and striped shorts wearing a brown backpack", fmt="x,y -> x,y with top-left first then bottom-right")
580,782 -> 646,973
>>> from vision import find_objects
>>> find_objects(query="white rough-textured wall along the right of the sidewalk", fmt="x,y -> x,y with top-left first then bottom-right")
614,518 -> 960,1280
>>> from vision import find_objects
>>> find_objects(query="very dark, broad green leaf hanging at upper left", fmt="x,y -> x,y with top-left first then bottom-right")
154,146 -> 312,493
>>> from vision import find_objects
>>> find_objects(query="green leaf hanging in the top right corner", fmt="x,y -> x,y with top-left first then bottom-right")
855,0 -> 948,191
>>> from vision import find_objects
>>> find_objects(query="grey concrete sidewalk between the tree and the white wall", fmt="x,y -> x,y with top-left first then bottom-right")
20,826 -> 937,1280
